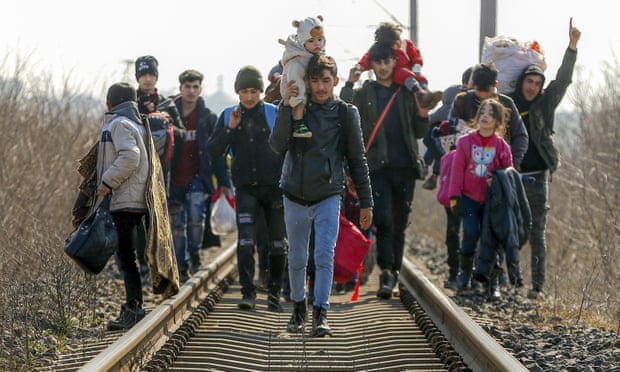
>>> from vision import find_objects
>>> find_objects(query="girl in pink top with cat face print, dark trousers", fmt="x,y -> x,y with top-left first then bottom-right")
448,98 -> 512,291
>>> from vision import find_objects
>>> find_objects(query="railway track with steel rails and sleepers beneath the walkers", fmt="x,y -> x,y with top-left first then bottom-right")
52,244 -> 526,371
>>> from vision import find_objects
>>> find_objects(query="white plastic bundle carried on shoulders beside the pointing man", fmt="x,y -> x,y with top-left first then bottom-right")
480,36 -> 547,94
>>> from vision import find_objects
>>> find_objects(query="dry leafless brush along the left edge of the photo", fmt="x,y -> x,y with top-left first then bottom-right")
0,53 -> 101,370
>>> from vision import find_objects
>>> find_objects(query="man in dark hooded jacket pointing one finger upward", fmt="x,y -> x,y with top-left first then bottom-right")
511,18 -> 581,299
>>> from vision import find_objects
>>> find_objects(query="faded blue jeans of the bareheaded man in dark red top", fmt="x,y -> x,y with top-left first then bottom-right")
168,177 -> 208,272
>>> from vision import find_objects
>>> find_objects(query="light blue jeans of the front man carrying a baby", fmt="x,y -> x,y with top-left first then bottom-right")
284,195 -> 340,309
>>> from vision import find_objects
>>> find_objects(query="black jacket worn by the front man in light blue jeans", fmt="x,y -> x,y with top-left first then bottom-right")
269,99 -> 373,208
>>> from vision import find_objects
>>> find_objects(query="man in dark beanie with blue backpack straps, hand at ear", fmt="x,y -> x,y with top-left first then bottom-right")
209,66 -> 286,312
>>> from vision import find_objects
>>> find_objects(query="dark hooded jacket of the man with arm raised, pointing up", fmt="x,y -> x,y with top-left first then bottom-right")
511,48 -> 577,172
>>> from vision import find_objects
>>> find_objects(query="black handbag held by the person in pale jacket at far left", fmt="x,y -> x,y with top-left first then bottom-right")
65,194 -> 118,274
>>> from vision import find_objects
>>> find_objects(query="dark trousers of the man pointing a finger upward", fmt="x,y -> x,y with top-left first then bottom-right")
523,171 -> 549,291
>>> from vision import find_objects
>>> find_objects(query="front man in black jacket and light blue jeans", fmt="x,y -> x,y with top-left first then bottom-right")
269,55 -> 372,337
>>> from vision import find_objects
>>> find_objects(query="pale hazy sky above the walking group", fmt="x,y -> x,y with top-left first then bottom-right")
0,0 -> 620,112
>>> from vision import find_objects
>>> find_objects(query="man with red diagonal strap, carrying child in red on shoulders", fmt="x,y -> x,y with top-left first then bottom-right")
340,43 -> 429,299
